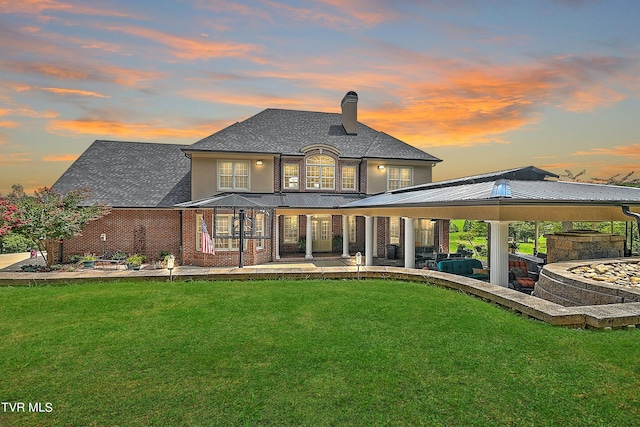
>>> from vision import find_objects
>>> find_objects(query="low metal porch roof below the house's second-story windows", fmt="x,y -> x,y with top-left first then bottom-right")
176,193 -> 366,209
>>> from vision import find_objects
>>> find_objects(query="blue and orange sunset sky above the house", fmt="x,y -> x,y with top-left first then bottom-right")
0,0 -> 640,194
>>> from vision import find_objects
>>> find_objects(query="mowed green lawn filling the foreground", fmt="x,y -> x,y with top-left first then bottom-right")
0,280 -> 640,426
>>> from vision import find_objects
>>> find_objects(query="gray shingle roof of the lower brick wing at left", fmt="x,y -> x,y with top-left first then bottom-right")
52,140 -> 191,208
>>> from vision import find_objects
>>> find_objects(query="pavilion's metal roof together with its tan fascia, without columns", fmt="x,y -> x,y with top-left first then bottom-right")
344,171 -> 640,221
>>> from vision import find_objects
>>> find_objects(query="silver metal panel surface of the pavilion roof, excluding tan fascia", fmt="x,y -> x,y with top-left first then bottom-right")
344,179 -> 640,208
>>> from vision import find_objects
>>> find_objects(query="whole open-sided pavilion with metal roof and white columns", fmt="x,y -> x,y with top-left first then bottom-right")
344,166 -> 640,287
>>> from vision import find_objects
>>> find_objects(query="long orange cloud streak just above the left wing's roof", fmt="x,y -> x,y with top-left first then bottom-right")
46,118 -> 224,141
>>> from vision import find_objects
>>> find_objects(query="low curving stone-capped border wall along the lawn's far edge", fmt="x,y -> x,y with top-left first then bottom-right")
0,254 -> 640,329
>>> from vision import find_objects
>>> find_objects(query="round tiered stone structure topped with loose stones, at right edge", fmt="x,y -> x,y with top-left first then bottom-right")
534,258 -> 640,307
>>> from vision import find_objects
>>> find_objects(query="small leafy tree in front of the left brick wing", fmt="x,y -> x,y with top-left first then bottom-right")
4,185 -> 110,267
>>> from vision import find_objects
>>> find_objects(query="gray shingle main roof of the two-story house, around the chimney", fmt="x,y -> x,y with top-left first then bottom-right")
185,108 -> 441,162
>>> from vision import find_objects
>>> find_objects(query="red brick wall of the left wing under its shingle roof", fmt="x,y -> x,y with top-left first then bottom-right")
60,208 -> 180,262
